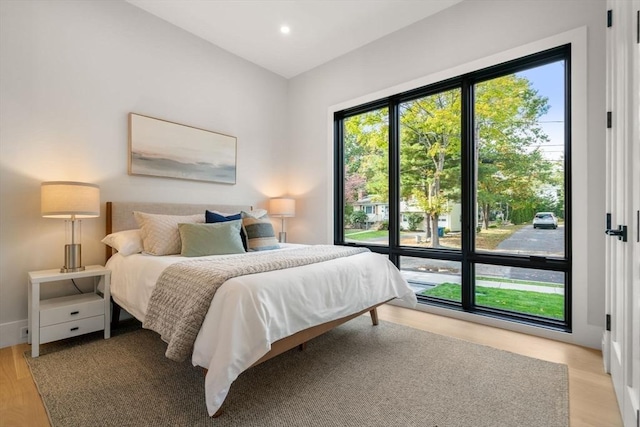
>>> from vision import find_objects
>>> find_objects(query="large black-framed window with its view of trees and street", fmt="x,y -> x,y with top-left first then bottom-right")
335,45 -> 571,330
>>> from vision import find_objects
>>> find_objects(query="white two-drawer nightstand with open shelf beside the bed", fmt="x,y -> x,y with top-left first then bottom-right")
28,265 -> 111,357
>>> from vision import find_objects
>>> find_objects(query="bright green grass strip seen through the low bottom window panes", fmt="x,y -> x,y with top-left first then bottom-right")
420,283 -> 564,320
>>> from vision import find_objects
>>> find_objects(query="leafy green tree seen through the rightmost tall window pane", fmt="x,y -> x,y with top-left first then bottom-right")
474,74 -> 551,229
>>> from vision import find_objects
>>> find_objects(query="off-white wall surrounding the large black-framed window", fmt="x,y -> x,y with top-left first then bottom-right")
289,0 -> 606,347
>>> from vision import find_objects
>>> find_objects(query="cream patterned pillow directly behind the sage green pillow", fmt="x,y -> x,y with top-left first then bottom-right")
133,211 -> 204,255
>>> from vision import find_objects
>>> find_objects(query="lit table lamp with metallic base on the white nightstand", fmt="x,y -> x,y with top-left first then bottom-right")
40,181 -> 100,273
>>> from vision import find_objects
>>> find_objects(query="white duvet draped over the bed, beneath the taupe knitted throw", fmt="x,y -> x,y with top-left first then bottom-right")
107,244 -> 416,415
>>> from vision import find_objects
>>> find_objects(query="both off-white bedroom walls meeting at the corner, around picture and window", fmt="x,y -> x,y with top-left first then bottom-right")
0,0 -> 605,347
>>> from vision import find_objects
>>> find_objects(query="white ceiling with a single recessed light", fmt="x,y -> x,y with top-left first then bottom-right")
127,0 -> 462,78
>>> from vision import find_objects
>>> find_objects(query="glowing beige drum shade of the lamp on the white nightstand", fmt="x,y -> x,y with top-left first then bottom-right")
40,181 -> 100,218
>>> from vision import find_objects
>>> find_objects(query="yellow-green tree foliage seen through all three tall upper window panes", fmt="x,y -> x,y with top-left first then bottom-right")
343,74 -> 564,236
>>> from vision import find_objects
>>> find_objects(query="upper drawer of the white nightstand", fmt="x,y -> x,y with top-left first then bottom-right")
40,293 -> 104,328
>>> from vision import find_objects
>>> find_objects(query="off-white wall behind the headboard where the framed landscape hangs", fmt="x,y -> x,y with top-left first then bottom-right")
0,0 -> 288,347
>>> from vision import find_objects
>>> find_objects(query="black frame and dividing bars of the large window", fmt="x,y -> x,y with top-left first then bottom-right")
334,44 -> 572,332
